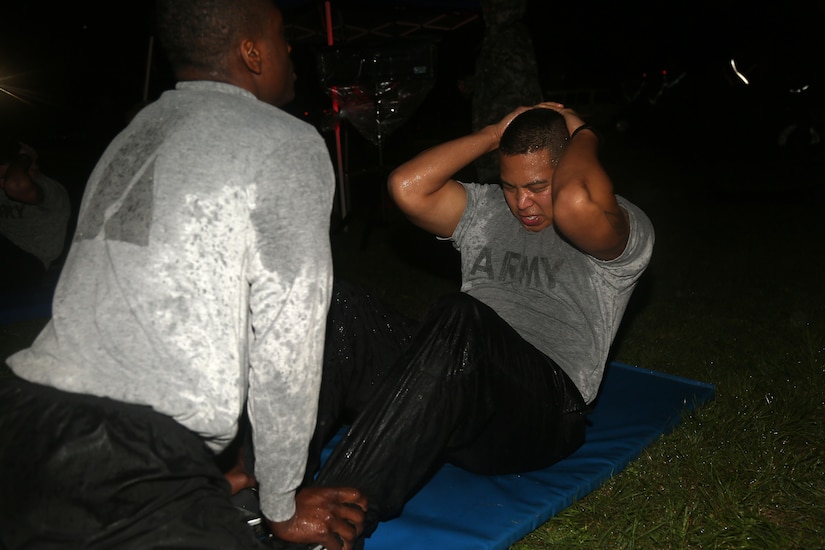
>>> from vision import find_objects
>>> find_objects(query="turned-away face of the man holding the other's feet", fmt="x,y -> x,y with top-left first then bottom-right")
261,6 -> 295,107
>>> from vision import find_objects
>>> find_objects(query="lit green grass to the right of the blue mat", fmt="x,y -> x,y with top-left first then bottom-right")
515,323 -> 825,550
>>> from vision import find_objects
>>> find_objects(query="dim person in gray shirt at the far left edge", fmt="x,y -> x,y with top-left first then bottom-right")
0,140 -> 71,291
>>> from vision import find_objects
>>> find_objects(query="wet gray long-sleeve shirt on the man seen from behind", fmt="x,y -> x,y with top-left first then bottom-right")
9,82 -> 334,521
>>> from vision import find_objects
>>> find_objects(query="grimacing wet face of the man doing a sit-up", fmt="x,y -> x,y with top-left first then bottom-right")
499,150 -> 554,232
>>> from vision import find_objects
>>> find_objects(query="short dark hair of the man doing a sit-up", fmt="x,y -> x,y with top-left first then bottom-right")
498,107 -> 570,166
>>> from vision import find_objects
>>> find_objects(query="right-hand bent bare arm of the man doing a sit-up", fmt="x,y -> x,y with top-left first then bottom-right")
541,103 -> 630,260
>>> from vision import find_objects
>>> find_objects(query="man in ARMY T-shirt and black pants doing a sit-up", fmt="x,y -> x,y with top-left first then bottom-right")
305,102 -> 654,535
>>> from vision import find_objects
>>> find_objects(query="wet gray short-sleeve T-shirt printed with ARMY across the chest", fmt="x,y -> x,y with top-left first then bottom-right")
451,184 -> 654,403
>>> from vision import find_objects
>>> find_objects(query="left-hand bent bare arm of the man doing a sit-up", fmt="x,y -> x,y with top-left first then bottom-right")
387,107 -> 525,237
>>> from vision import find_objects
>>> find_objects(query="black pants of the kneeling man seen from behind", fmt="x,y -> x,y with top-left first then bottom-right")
0,376 -> 265,550
